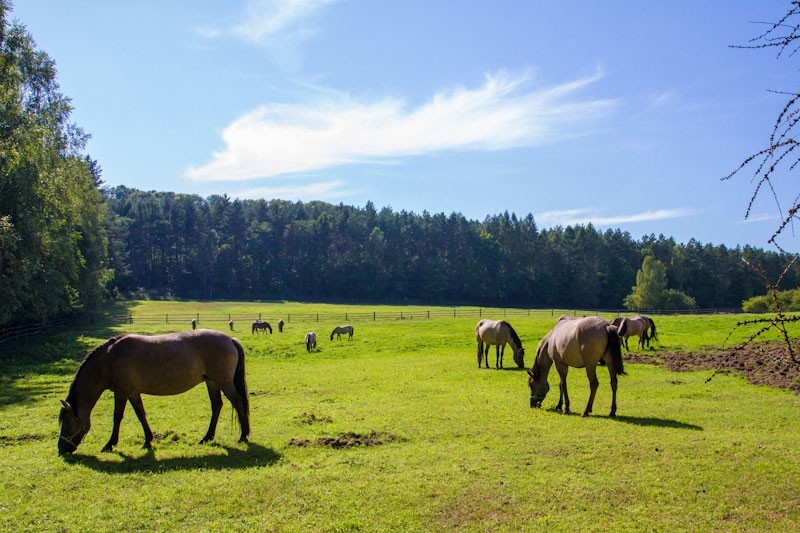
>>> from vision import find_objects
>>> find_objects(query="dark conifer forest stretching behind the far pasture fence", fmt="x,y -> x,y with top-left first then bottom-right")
104,186 -> 800,308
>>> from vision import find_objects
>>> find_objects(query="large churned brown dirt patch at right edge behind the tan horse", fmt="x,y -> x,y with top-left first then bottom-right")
623,340 -> 800,395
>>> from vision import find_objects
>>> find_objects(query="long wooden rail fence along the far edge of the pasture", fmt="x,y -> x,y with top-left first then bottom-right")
0,307 -> 743,345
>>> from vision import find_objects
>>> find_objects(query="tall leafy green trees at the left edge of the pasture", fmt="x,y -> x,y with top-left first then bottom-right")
0,0 -> 111,325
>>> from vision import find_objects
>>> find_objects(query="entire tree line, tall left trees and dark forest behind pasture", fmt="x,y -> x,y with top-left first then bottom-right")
0,0 -> 800,326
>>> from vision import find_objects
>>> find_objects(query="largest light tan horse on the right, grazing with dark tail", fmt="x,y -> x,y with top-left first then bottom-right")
528,316 -> 625,417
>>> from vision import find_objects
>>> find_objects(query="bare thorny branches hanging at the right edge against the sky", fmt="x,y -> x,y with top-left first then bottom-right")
720,0 -> 800,380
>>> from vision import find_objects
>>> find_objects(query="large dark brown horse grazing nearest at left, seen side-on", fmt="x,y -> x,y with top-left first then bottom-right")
58,329 -> 250,455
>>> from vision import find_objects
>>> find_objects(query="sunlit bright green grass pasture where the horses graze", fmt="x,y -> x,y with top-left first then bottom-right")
0,302 -> 800,531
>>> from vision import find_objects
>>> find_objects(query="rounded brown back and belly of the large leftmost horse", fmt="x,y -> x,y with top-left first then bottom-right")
109,330 -> 239,395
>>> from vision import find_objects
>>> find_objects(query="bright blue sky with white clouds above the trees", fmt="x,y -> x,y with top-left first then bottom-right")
11,0 -> 800,250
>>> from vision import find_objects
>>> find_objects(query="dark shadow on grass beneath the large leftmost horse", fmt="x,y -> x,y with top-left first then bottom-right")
64,443 -> 281,474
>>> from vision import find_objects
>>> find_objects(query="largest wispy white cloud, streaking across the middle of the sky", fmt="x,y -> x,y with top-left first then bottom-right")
186,72 -> 617,180
